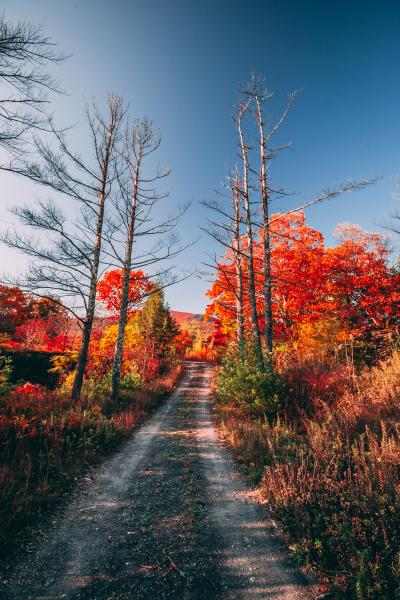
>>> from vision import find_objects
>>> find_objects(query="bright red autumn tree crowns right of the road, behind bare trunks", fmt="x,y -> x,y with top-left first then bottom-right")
207,212 -> 400,352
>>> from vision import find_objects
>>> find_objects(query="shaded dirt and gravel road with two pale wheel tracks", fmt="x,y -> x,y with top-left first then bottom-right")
0,363 -> 315,600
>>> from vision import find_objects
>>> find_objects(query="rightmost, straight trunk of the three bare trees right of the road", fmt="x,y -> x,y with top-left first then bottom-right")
255,96 -> 273,362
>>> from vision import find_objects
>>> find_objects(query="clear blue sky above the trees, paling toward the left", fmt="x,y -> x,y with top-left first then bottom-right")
0,0 -> 400,312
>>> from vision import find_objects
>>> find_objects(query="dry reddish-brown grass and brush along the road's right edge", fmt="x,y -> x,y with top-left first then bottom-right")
215,352 -> 400,600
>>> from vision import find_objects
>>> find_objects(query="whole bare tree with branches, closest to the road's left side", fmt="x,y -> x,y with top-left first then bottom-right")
106,117 -> 187,399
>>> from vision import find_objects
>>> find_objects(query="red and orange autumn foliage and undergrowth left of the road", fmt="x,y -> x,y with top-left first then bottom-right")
0,272 -> 186,542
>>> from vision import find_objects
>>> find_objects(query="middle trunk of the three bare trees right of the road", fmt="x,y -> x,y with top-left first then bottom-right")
237,105 -> 264,369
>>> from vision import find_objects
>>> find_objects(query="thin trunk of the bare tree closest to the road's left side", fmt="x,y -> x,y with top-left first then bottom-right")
111,148 -> 142,400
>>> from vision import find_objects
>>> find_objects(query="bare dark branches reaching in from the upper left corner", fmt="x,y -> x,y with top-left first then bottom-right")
0,15 -> 65,157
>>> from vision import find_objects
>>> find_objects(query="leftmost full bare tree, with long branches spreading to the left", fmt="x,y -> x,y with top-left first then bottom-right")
3,96 -> 124,399
